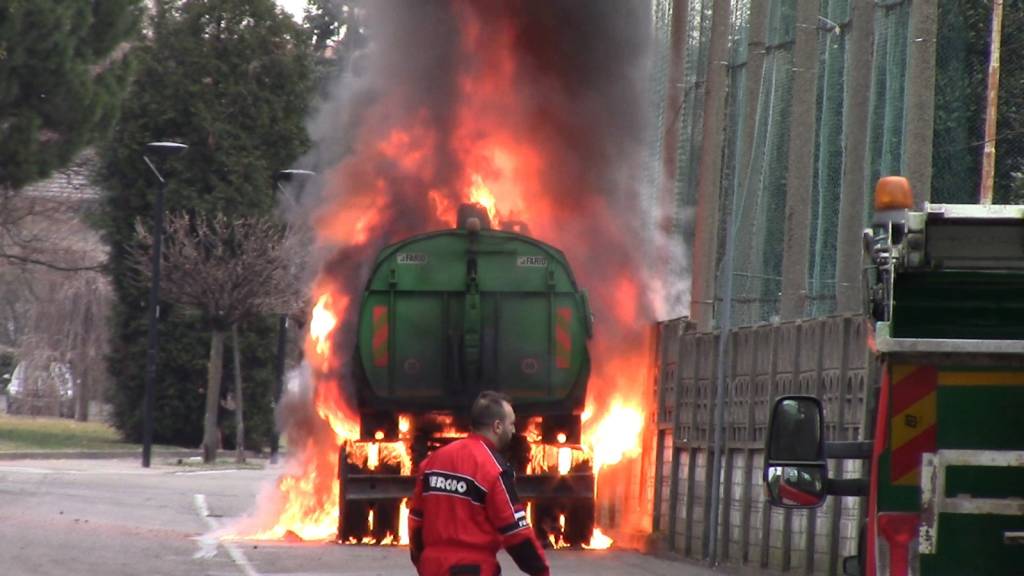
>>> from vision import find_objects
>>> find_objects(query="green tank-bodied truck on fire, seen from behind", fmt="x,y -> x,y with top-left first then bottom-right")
338,204 -> 595,546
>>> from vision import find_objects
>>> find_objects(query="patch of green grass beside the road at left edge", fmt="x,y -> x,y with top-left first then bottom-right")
0,414 -> 138,452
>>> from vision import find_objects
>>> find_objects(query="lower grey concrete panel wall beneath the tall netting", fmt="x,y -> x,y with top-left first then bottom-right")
653,316 -> 874,574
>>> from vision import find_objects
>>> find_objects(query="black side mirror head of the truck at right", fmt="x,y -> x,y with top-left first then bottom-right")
764,396 -> 828,508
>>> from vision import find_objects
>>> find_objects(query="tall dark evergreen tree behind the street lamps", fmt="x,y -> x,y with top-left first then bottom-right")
102,0 -> 312,447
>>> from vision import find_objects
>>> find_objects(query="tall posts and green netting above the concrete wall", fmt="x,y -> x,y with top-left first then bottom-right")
649,0 -> 1024,328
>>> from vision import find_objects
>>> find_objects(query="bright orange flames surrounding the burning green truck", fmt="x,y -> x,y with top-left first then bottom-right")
222,0 -> 651,548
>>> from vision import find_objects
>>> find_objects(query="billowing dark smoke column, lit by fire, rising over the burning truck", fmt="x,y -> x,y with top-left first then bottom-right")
256,0 -> 686,545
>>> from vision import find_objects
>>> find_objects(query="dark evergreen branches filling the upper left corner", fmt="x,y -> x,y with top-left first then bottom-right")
0,0 -> 142,189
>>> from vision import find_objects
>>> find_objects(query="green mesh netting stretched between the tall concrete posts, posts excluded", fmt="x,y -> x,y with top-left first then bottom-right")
648,0 -> 1024,324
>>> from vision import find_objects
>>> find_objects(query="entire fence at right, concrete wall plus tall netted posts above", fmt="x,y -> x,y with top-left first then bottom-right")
651,0 -> 1024,574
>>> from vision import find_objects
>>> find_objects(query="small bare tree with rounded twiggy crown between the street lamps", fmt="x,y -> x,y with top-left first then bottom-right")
131,213 -> 303,462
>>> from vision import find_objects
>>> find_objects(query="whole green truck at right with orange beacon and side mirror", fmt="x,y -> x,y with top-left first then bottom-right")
764,176 -> 1024,576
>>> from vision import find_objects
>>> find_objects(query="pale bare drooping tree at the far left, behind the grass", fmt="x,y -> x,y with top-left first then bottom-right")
0,153 -> 113,420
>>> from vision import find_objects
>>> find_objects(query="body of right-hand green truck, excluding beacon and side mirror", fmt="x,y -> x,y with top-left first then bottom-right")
868,204 -> 1024,576
